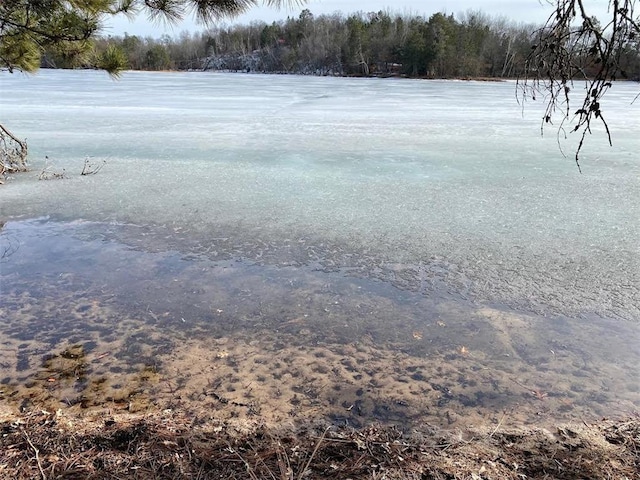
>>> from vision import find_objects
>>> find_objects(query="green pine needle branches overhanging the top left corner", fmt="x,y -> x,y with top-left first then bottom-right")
0,0 -> 305,73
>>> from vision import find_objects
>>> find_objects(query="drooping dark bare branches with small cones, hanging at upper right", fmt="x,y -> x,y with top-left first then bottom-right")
519,0 -> 640,168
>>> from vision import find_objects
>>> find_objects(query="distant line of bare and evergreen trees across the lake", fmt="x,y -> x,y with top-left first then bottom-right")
43,10 -> 640,79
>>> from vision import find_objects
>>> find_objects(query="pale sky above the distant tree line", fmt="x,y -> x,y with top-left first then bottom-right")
103,0 -> 608,37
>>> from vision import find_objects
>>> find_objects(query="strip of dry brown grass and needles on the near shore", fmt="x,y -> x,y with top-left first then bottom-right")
0,412 -> 640,480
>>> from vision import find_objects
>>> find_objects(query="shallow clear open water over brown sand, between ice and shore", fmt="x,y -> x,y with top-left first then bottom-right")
0,219 -> 640,426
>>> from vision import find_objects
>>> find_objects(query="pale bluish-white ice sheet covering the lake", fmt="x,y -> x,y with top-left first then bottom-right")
0,70 -> 640,320
